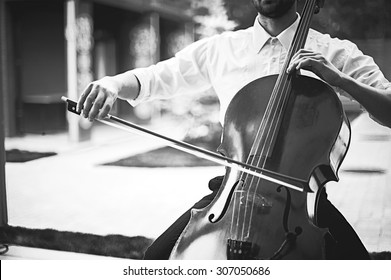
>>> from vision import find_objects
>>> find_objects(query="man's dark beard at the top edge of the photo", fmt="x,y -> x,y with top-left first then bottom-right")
252,0 -> 296,18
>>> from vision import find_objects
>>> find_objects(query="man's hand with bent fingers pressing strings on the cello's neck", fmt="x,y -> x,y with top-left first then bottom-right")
287,49 -> 343,86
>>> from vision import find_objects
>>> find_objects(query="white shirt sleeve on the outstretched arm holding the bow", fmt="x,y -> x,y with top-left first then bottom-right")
129,38 -> 212,106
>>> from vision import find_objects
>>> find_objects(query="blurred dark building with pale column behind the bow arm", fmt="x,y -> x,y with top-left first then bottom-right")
0,0 -> 194,141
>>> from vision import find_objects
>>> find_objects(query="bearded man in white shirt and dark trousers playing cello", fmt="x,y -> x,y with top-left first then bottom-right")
78,0 -> 391,259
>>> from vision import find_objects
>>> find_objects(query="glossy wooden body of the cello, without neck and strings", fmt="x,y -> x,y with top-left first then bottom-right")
170,75 -> 350,259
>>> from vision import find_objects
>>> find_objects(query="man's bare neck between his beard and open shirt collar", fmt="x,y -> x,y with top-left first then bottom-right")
258,5 -> 297,37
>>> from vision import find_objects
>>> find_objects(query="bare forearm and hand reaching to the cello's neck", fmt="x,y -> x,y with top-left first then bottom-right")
287,50 -> 391,127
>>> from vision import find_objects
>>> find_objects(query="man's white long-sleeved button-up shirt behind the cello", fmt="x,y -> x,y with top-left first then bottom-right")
130,14 -> 391,121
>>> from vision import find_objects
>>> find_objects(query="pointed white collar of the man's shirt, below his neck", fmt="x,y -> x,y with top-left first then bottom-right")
253,14 -> 300,53
